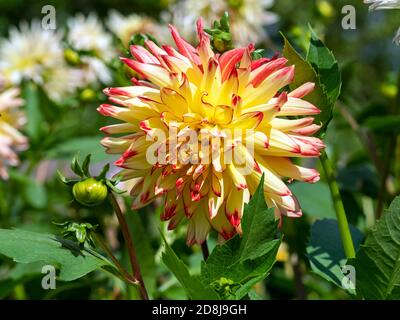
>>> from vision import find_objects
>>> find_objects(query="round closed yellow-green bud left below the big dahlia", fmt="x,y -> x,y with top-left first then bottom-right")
72,178 -> 108,207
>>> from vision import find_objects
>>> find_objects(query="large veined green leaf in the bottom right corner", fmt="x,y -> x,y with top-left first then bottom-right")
353,197 -> 400,300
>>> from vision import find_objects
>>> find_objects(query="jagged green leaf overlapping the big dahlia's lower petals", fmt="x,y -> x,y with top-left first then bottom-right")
201,178 -> 281,299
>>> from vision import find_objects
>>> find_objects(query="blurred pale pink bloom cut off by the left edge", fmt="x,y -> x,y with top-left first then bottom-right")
0,84 -> 27,179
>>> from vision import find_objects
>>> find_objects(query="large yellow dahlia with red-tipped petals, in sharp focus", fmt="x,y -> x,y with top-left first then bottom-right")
98,20 -> 324,245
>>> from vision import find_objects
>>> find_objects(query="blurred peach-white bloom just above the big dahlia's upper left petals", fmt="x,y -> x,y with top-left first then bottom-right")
107,10 -> 164,46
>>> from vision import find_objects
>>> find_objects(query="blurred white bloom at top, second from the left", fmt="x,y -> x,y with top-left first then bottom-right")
67,13 -> 114,61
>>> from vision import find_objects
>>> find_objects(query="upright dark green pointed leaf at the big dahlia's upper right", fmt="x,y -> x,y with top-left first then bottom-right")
307,25 -> 342,106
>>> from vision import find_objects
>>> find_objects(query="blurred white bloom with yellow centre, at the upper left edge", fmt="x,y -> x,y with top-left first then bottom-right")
0,21 -> 63,84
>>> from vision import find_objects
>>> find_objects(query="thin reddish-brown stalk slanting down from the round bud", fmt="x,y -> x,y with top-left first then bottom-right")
108,192 -> 149,300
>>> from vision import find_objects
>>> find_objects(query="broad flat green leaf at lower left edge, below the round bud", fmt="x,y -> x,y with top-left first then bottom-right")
0,229 -> 117,281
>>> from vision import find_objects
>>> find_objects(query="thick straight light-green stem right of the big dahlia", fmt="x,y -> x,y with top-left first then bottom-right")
320,151 -> 356,259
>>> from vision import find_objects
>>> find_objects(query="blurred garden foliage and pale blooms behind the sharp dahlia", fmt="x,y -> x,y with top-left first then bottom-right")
0,0 -> 400,299
